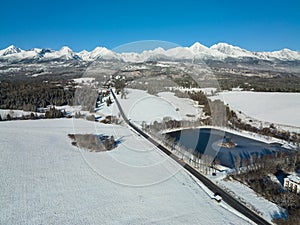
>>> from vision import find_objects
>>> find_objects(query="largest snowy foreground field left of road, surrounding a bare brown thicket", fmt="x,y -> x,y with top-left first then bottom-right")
0,119 -> 253,224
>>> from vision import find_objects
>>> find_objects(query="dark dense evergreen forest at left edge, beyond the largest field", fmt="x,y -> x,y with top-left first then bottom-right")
0,81 -> 75,112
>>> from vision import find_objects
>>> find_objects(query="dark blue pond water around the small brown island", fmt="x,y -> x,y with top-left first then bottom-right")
168,128 -> 288,168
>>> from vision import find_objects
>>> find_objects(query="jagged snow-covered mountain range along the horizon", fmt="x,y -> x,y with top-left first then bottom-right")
0,42 -> 300,62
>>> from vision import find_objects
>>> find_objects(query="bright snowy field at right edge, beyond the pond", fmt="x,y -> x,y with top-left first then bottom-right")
211,91 -> 300,127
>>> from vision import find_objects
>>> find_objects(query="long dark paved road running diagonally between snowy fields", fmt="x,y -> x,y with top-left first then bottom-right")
111,90 -> 270,225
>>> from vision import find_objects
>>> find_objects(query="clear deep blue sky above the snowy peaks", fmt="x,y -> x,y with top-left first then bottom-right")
0,0 -> 300,51
